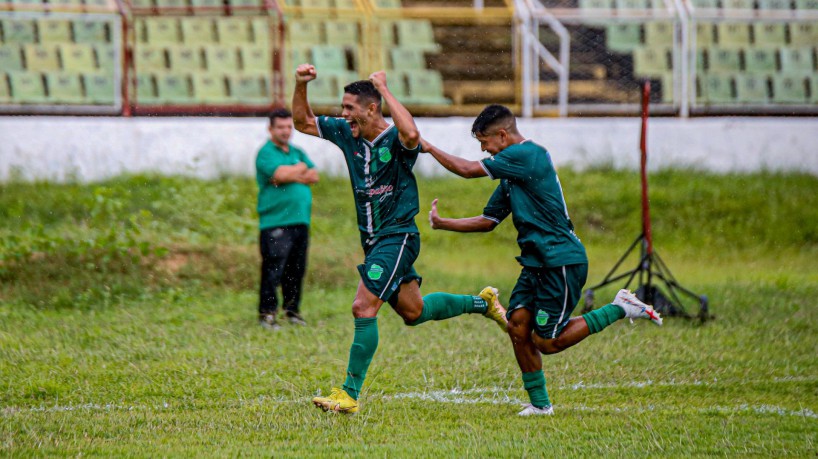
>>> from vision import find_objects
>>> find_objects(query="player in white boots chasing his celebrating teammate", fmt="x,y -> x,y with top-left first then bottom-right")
422,105 -> 662,416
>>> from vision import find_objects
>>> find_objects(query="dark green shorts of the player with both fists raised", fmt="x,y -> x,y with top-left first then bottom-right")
358,233 -> 422,306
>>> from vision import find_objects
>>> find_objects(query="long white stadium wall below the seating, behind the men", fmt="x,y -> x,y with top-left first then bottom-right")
0,117 -> 818,182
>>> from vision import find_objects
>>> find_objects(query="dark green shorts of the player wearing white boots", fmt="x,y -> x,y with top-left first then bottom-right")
506,263 -> 588,339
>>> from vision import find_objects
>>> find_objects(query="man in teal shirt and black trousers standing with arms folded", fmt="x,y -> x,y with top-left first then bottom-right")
256,109 -> 318,330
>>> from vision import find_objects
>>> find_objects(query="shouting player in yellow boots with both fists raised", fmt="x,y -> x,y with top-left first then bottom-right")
293,64 -> 506,414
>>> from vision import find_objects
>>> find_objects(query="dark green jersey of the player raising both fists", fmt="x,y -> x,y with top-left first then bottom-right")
317,116 -> 420,243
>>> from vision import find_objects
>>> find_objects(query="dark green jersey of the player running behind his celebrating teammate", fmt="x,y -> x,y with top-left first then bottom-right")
481,140 -> 588,268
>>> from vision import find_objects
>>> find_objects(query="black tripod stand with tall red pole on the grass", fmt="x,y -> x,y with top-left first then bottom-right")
584,81 -> 713,322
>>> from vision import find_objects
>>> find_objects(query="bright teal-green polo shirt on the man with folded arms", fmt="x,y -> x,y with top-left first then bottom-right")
256,140 -> 315,230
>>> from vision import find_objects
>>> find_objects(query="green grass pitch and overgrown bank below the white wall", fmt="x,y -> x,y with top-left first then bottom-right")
0,170 -> 818,458
